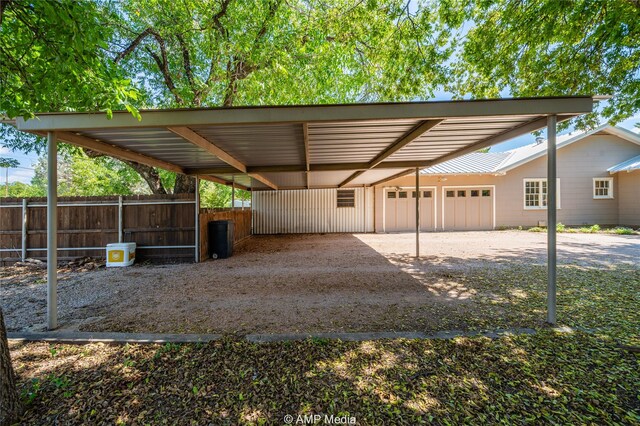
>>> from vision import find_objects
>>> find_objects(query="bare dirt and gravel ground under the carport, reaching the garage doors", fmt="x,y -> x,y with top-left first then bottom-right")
0,231 -> 640,334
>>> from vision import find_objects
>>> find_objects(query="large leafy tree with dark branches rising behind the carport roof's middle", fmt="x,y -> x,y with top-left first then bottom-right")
100,0 -> 450,192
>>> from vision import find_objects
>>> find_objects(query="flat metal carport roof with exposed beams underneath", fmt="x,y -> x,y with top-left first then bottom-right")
15,96 -> 594,189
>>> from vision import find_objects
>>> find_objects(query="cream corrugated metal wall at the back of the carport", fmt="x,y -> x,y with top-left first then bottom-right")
253,188 -> 373,234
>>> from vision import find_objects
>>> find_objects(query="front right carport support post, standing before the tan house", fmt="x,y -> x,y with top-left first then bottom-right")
547,115 -> 557,324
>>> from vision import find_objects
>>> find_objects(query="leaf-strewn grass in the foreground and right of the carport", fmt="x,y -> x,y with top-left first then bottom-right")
11,265 -> 640,425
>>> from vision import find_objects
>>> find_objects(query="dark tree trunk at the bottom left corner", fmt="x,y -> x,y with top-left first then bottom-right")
0,307 -> 22,426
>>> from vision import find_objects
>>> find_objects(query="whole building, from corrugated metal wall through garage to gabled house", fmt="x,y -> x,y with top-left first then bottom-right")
253,126 -> 640,234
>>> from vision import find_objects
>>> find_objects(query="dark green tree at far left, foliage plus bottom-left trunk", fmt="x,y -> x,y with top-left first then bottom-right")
0,0 -> 137,422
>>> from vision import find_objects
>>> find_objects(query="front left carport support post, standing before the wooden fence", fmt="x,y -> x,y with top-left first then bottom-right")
47,132 -> 58,330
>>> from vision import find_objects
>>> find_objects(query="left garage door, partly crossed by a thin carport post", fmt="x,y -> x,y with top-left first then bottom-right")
384,188 -> 436,232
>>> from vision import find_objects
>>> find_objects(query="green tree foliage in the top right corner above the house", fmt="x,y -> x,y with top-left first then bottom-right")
441,0 -> 640,125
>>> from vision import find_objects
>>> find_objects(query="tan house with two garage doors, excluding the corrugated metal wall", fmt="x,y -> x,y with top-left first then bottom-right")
375,126 -> 640,232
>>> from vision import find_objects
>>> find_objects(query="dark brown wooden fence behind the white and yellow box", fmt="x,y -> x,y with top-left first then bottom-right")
0,194 -> 195,264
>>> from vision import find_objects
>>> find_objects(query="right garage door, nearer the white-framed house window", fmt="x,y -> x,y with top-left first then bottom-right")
442,186 -> 495,231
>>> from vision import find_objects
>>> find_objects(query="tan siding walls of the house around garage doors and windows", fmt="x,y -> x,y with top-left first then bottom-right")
375,133 -> 640,232
